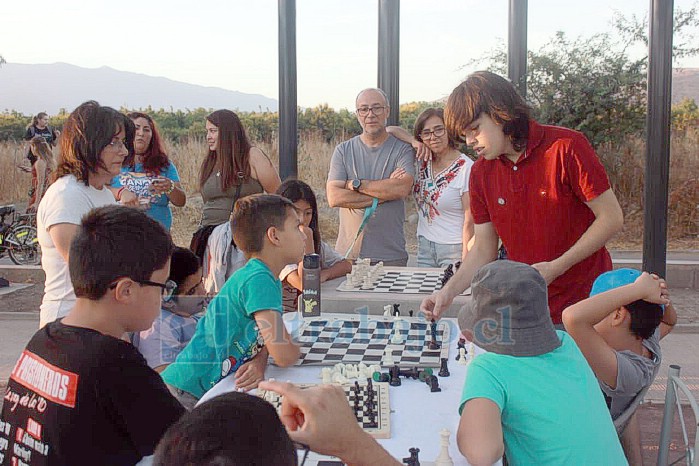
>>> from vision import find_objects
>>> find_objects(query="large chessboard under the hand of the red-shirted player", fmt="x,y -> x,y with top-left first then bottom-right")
288,314 -> 450,367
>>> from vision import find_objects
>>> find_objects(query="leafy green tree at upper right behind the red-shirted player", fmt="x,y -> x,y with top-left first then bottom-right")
472,6 -> 699,146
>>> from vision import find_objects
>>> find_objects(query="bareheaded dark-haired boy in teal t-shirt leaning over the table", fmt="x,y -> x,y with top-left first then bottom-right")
162,194 -> 305,409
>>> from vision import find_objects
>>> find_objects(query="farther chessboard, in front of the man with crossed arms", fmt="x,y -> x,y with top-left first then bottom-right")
337,270 -> 444,294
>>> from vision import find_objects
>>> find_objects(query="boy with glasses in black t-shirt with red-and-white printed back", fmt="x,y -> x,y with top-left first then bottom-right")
0,206 -> 184,466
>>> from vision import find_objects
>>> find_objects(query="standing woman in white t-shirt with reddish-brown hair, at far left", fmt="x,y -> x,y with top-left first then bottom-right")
37,101 -> 134,327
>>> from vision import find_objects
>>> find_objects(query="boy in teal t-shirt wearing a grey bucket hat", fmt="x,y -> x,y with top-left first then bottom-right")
457,261 -> 627,466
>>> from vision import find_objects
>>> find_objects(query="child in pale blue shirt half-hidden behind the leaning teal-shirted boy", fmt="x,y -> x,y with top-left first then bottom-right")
131,247 -> 209,372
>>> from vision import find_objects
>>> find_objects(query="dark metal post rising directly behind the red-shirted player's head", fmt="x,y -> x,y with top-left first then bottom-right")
507,0 -> 528,98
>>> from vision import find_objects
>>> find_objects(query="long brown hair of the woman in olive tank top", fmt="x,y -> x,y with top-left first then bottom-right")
199,110 -> 251,192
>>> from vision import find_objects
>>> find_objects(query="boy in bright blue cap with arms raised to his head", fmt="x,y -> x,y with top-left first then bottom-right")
563,269 -> 677,464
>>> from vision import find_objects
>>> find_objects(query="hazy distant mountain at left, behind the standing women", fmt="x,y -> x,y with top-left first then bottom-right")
0,63 -> 278,114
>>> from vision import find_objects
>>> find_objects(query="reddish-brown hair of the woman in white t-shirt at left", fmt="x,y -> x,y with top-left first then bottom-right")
54,100 -> 136,186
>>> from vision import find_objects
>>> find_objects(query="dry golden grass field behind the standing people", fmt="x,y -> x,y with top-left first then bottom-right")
0,130 -> 699,252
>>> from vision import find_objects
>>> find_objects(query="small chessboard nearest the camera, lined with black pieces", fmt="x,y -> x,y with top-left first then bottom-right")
257,379 -> 391,439
